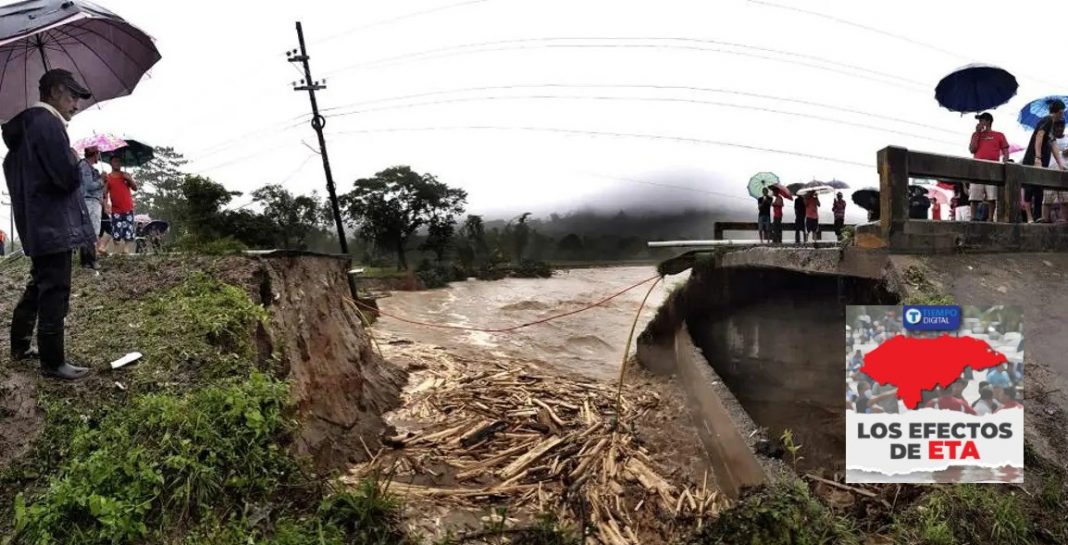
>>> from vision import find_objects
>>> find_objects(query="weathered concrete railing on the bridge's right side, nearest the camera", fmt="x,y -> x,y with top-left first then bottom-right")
878,146 -> 1068,231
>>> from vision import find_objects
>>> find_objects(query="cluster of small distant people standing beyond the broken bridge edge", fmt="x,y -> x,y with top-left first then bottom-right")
756,187 -> 846,244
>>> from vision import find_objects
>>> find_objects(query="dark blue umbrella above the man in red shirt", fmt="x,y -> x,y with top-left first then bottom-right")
935,64 -> 1020,113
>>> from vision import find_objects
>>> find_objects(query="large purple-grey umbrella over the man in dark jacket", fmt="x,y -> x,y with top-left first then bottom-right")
0,0 -> 160,121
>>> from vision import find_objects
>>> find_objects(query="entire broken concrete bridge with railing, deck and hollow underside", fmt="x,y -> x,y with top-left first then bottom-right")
639,147 -> 1068,495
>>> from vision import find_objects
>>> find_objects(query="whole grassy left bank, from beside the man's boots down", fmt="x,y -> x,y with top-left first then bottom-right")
0,263 -> 409,545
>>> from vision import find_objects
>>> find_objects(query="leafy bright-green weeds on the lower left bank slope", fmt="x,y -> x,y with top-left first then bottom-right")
15,374 -> 298,545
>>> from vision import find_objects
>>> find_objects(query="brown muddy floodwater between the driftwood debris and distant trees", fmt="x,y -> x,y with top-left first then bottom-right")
375,266 -> 688,380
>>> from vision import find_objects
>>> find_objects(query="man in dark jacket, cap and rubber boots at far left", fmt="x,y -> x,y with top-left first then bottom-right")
2,69 -> 94,379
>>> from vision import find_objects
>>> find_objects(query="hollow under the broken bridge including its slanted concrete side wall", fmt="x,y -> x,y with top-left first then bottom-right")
639,252 -> 898,493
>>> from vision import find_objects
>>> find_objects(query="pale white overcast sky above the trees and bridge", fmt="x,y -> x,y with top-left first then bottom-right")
3,0 -> 1066,229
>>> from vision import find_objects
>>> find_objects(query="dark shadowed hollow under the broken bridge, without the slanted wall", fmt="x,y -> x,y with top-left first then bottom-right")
686,268 -> 896,471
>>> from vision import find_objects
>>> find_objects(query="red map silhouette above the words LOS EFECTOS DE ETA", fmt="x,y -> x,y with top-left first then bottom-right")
861,334 -> 1008,409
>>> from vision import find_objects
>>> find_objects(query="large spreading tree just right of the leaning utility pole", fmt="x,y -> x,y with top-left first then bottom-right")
342,167 -> 467,270
